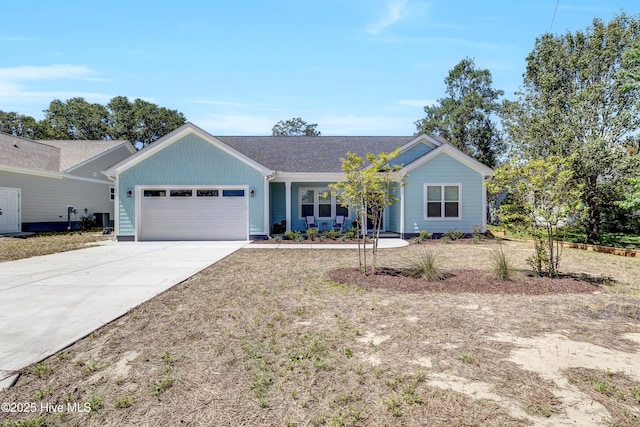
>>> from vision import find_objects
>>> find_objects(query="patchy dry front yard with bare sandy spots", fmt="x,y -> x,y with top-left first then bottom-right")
0,240 -> 640,426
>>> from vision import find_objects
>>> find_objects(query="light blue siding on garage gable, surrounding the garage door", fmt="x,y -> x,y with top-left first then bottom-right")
118,134 -> 268,236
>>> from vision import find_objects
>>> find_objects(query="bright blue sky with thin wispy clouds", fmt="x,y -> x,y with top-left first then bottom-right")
0,0 -> 640,135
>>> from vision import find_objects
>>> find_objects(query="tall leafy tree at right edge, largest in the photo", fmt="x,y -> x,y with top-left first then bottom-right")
501,14 -> 640,242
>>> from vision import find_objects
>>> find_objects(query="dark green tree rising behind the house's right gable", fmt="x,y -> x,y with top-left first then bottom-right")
415,58 -> 504,167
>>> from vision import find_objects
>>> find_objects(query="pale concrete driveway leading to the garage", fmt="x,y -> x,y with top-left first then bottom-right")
0,241 -> 248,389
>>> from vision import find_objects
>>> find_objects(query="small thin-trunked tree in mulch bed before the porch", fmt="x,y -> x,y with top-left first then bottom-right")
329,150 -> 404,274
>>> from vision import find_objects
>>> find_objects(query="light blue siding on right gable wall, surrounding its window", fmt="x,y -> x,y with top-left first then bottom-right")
404,153 -> 486,233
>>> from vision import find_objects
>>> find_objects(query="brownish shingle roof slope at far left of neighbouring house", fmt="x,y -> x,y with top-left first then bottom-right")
0,132 -> 60,172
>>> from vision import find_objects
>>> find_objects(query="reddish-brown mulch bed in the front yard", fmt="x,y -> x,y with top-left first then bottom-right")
329,267 -> 598,295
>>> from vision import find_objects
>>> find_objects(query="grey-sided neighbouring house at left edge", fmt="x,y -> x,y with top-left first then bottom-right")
0,133 -> 135,233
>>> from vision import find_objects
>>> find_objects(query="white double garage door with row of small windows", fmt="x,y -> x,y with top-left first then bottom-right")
138,186 -> 249,240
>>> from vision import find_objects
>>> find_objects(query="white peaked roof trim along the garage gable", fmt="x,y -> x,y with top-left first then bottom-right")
102,123 -> 273,176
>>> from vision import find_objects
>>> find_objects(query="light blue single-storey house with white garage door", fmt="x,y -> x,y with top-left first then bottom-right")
104,123 -> 492,241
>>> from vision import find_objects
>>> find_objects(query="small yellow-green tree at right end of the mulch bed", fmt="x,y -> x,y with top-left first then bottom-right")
487,156 -> 582,277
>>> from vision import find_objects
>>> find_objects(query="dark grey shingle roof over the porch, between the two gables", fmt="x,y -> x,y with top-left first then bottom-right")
215,136 -> 415,172
